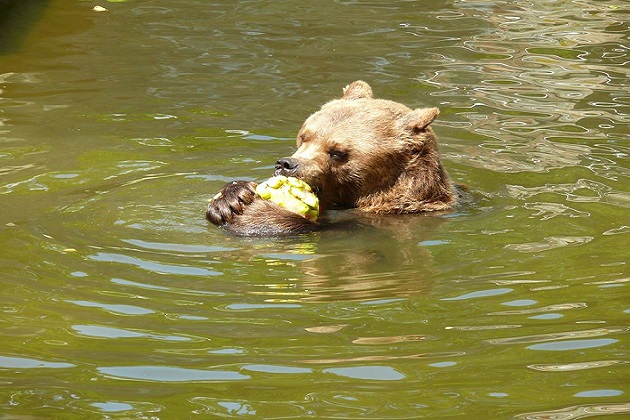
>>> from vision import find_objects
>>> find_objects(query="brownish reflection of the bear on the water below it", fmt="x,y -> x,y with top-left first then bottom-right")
230,211 -> 447,302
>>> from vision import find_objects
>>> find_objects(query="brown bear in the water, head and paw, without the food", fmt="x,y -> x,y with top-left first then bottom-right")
206,80 -> 457,235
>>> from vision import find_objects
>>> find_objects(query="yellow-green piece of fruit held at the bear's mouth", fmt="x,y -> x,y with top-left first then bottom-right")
256,175 -> 319,222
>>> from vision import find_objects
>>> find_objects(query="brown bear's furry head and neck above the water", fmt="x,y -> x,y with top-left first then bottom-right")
276,81 -> 452,213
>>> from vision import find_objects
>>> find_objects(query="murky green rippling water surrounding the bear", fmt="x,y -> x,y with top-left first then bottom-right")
0,0 -> 630,419
